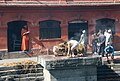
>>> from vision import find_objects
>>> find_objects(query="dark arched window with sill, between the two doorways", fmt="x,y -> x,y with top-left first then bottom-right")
39,20 -> 61,39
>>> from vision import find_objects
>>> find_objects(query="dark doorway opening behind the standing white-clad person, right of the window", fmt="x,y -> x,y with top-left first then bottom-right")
68,20 -> 88,41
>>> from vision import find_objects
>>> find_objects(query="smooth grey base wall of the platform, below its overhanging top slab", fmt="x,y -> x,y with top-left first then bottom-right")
44,66 -> 97,81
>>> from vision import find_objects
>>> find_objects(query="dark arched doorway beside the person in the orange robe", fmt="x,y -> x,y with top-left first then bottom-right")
7,20 -> 27,52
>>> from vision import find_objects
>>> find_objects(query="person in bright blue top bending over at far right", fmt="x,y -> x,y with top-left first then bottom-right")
104,45 -> 114,63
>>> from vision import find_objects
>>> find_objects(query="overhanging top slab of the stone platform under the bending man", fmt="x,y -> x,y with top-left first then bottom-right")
39,55 -> 102,70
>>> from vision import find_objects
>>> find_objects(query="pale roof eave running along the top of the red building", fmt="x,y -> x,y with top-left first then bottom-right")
0,1 -> 120,7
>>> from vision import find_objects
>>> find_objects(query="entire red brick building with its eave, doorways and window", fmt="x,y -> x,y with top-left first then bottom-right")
0,0 -> 120,52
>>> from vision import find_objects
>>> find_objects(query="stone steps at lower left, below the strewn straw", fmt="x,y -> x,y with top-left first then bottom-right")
0,65 -> 44,81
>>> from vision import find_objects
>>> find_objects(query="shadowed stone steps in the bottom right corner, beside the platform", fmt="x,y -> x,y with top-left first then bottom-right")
97,64 -> 120,81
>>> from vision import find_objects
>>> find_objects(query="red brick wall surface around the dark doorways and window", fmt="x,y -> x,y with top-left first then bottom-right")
0,7 -> 120,50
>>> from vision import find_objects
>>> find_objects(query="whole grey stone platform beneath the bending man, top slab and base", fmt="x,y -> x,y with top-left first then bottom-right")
39,55 -> 102,81
